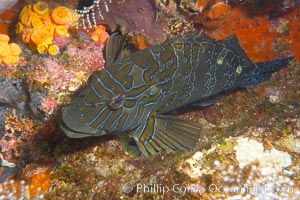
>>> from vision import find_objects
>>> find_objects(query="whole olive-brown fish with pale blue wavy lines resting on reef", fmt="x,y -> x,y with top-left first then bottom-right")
60,32 -> 293,157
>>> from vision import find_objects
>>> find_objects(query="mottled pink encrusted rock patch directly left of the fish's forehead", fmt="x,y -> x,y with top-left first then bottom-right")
29,39 -> 105,114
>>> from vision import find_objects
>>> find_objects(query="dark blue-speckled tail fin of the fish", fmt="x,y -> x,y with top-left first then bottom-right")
242,56 -> 293,88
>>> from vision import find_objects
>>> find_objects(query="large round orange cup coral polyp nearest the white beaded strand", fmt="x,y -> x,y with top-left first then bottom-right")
51,6 -> 72,25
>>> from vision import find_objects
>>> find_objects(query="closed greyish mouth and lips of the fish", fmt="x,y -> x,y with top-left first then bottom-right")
60,108 -> 107,138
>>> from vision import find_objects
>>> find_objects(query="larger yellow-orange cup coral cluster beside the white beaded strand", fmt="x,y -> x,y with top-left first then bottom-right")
16,1 -> 78,55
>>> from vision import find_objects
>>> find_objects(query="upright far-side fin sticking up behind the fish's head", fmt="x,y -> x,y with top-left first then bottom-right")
104,32 -> 127,67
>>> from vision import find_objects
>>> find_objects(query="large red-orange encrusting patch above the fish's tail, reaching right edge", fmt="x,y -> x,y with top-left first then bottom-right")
201,6 -> 300,62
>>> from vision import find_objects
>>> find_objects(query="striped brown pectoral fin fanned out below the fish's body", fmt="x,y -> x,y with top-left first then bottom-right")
130,115 -> 201,157
